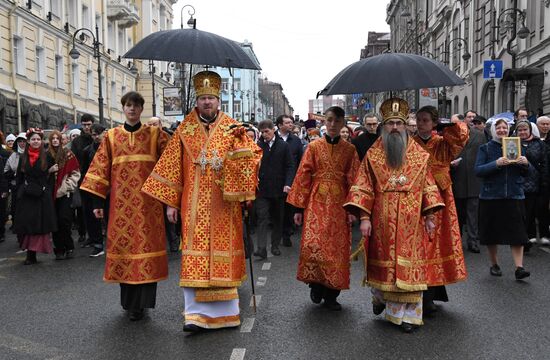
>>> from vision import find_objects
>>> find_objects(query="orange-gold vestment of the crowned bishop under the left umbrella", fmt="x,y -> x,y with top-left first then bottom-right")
142,110 -> 261,294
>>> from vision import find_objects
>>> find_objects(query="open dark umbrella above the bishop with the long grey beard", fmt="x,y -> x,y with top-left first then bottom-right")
317,53 -> 464,95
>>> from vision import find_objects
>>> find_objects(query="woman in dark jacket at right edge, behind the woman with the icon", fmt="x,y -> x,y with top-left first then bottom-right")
515,120 -> 550,246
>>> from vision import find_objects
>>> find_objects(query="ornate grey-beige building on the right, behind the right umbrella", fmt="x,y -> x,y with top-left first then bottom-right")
386,0 -> 550,117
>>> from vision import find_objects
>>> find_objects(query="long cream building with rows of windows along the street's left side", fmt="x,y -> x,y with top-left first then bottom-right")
0,0 -> 175,133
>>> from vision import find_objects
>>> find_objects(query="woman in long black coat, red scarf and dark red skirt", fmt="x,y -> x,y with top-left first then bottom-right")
15,128 -> 58,265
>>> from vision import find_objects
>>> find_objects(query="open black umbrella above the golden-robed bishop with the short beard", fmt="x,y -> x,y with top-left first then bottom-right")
124,29 -> 261,70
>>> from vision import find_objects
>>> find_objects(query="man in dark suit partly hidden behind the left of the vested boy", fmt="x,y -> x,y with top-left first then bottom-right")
276,115 -> 304,247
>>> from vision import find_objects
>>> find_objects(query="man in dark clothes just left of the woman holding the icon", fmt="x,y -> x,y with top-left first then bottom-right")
451,110 -> 487,254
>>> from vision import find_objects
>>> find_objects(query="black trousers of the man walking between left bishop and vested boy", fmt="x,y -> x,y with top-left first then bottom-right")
255,197 -> 285,250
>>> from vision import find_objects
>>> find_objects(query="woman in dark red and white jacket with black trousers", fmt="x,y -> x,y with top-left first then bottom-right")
48,130 -> 80,260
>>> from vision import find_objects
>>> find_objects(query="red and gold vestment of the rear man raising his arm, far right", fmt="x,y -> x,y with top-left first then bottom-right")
413,123 -> 468,286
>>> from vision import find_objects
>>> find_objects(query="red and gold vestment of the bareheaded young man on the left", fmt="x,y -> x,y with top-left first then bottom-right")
80,126 -> 168,284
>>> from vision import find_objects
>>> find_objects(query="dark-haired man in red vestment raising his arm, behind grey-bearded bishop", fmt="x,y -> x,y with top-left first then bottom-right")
413,106 -> 468,313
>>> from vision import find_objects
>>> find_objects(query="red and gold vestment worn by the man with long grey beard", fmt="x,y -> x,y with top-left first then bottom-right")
344,139 -> 444,302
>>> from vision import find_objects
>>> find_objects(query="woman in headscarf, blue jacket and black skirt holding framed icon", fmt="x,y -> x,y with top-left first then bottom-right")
475,119 -> 531,280
